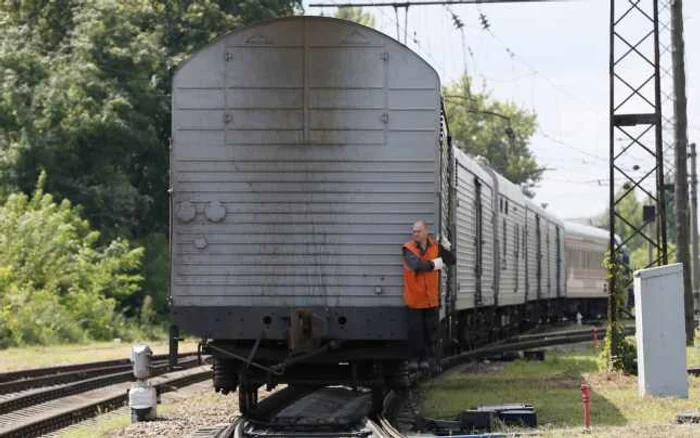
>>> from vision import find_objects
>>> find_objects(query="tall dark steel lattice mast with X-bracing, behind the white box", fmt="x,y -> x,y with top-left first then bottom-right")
608,0 -> 668,357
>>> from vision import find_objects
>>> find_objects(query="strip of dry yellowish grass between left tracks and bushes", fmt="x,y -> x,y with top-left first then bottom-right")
0,340 -> 197,372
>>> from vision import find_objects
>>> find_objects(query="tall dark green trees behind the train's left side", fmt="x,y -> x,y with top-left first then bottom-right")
0,0 -> 300,328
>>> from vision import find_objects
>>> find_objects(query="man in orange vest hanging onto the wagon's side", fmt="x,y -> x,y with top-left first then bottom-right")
403,220 -> 455,371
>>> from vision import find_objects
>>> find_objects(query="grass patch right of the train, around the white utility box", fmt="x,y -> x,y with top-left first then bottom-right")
421,347 -> 700,436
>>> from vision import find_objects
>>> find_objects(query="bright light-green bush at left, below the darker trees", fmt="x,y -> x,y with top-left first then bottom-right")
0,173 -> 143,346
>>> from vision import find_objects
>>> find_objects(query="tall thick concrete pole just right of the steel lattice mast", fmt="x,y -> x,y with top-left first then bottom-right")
671,0 -> 695,345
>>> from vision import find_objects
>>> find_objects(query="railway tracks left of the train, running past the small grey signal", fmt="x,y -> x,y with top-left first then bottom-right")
0,353 -> 211,437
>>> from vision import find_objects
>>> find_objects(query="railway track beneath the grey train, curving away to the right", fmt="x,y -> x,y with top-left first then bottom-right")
191,328 -> 634,438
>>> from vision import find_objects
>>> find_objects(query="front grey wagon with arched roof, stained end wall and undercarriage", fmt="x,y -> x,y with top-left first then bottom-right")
171,17 -> 441,410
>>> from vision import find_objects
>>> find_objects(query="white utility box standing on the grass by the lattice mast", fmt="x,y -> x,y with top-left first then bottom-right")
634,263 -> 688,398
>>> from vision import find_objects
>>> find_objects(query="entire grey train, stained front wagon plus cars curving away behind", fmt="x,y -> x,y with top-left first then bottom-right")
170,17 -> 624,412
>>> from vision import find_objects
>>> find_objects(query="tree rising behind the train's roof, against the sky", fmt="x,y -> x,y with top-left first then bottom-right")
443,76 -> 544,196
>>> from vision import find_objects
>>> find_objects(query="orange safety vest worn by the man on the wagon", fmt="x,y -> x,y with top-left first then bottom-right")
403,238 -> 440,309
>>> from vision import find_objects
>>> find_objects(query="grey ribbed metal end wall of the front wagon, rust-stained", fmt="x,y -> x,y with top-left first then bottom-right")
172,17 -> 440,306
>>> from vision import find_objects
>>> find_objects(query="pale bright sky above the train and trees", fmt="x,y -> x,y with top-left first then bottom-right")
304,0 -> 700,219
